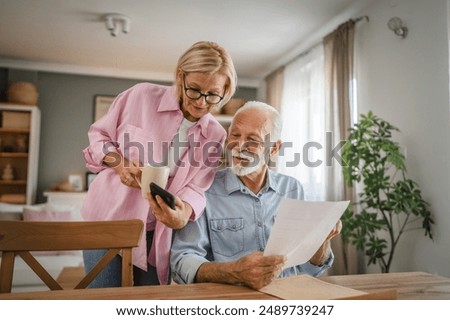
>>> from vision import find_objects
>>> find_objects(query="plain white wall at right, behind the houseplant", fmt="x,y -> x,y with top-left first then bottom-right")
356,0 -> 450,276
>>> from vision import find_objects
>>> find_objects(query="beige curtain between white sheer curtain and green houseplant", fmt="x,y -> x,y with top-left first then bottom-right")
323,20 -> 362,274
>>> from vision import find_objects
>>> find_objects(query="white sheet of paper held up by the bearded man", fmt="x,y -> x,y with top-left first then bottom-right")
264,198 -> 350,268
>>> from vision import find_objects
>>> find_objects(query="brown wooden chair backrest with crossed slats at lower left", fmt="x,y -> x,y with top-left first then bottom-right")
0,220 -> 144,293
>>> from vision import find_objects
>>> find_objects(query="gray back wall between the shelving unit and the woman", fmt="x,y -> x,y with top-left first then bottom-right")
0,69 -> 256,202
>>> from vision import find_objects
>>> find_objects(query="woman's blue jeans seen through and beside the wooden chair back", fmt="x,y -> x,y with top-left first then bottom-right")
83,231 -> 159,288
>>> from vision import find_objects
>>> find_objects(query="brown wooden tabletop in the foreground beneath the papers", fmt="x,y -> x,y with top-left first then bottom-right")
0,272 -> 450,300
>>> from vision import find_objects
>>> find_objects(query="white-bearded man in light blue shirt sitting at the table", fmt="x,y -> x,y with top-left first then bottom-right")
171,101 -> 341,289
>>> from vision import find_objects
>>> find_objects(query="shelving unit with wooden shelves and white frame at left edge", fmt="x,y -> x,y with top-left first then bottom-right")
0,103 -> 41,205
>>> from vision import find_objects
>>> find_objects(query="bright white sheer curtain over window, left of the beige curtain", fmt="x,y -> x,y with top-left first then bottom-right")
277,44 -> 326,200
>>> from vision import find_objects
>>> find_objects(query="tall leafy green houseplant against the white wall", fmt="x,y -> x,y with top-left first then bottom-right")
342,112 -> 434,273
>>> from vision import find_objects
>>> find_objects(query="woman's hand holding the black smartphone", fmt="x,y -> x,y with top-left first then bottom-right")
147,192 -> 192,229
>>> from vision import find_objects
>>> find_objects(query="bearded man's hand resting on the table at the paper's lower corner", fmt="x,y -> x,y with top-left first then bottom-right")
233,252 -> 285,290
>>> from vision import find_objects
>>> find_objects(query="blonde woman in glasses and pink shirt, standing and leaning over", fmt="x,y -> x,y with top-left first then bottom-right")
81,42 -> 236,287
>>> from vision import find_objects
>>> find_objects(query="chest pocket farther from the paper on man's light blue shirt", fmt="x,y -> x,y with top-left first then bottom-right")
209,218 -> 244,257
